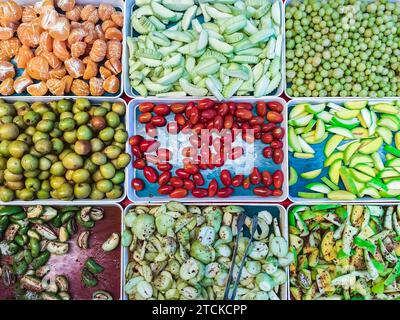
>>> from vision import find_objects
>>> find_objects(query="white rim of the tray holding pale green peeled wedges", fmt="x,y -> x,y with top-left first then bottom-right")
123,0 -> 286,100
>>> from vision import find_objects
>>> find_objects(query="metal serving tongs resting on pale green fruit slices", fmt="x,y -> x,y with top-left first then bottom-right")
224,213 -> 258,300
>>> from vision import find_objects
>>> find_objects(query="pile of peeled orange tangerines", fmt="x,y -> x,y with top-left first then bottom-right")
0,0 -> 123,96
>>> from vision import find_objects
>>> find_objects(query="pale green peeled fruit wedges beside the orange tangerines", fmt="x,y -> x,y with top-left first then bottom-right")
127,0 -> 283,100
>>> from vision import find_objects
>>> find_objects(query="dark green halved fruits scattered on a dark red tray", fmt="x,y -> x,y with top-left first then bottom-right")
0,205 -> 121,300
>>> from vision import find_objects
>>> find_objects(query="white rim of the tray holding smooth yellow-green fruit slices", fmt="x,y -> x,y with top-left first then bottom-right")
286,97 -> 399,204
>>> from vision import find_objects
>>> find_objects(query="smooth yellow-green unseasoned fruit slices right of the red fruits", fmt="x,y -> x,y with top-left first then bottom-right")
288,101 -> 400,200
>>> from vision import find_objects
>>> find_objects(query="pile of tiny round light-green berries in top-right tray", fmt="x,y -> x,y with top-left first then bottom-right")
286,0 -> 400,98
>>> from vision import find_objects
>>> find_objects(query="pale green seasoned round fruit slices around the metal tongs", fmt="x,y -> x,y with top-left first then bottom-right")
122,201 -> 293,300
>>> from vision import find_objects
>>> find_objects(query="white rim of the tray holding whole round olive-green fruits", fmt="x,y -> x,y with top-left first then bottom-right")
0,96 -> 130,206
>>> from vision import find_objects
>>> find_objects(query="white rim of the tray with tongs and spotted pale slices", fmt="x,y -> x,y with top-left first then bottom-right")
121,202 -> 290,300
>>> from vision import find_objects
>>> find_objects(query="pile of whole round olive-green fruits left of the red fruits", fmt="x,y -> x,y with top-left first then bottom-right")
0,98 -> 130,202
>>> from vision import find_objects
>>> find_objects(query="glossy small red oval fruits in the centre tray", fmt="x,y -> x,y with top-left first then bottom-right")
129,99 -> 285,198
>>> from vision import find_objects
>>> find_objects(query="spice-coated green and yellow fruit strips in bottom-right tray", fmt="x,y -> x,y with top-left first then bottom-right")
289,204 -> 400,300
